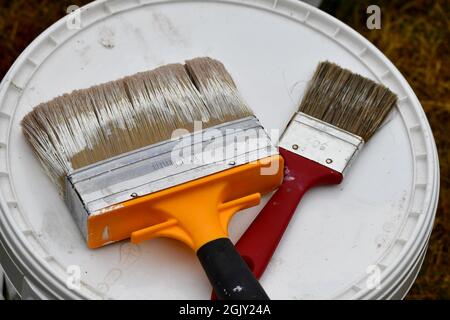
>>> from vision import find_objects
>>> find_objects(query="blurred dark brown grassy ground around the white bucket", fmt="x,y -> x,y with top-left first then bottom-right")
0,0 -> 450,299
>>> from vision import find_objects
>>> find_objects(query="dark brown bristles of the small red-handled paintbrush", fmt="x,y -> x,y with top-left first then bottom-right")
299,61 -> 397,142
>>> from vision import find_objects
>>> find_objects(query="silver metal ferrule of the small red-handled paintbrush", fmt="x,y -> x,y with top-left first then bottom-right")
279,112 -> 364,174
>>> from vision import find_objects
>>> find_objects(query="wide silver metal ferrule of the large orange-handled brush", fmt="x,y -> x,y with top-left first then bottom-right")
65,117 -> 278,237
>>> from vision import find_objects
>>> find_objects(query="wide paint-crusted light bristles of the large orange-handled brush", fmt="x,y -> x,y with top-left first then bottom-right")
22,58 -> 252,191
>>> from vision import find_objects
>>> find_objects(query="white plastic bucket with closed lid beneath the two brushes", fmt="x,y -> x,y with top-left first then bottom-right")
0,0 -> 439,299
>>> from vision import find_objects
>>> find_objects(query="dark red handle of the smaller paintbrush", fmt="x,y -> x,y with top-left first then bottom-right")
213,148 -> 343,298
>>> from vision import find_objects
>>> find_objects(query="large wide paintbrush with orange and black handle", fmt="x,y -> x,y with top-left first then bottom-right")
22,58 -> 283,299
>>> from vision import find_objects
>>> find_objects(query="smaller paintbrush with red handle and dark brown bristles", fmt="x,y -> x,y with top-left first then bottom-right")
212,62 -> 397,296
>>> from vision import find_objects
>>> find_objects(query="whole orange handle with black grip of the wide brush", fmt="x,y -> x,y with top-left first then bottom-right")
87,156 -> 283,300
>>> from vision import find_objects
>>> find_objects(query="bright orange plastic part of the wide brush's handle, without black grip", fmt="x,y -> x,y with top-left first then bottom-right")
87,155 -> 283,251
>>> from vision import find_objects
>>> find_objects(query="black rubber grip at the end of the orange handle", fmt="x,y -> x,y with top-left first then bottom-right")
197,238 -> 269,300
